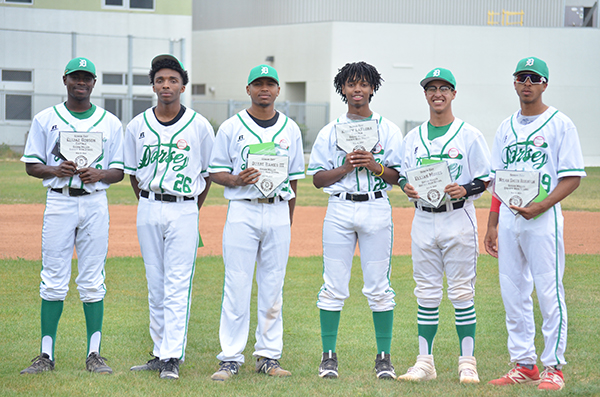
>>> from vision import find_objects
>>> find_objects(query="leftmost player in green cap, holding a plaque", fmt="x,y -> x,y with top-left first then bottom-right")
21,58 -> 123,374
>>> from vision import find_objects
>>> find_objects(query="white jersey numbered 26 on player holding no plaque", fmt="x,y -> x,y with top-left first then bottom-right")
124,108 -> 214,197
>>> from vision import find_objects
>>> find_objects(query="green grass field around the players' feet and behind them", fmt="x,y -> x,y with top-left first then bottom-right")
0,160 -> 600,396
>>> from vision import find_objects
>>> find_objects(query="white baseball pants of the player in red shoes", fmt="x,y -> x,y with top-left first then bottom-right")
498,204 -> 567,366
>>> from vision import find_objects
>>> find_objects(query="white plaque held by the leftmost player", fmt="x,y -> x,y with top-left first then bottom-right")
59,131 -> 102,169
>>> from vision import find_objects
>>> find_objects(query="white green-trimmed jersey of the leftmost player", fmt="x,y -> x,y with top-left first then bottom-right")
21,103 -> 123,189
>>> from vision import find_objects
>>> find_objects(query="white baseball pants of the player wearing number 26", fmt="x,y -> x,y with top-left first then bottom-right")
137,195 -> 198,361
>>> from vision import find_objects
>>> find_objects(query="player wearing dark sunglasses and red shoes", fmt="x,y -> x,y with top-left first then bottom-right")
485,57 -> 586,390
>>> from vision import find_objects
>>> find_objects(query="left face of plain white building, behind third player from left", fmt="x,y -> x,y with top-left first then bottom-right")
192,23 -> 333,102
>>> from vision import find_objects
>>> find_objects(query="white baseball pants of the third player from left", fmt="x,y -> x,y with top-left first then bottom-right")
217,200 -> 291,363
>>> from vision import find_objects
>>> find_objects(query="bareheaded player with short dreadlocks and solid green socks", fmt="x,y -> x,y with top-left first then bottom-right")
308,62 -> 402,379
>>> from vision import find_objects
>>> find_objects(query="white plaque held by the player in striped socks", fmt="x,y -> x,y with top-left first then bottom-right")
406,161 -> 452,208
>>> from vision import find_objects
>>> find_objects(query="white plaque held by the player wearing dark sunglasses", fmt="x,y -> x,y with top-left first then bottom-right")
494,170 -> 540,215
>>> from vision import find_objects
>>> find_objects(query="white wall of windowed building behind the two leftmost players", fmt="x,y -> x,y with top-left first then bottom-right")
0,7 -> 192,149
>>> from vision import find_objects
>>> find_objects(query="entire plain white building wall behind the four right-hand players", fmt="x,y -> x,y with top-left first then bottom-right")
193,22 -> 600,166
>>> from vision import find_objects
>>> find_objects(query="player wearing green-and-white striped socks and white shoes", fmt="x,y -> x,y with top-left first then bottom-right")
398,68 -> 490,383
